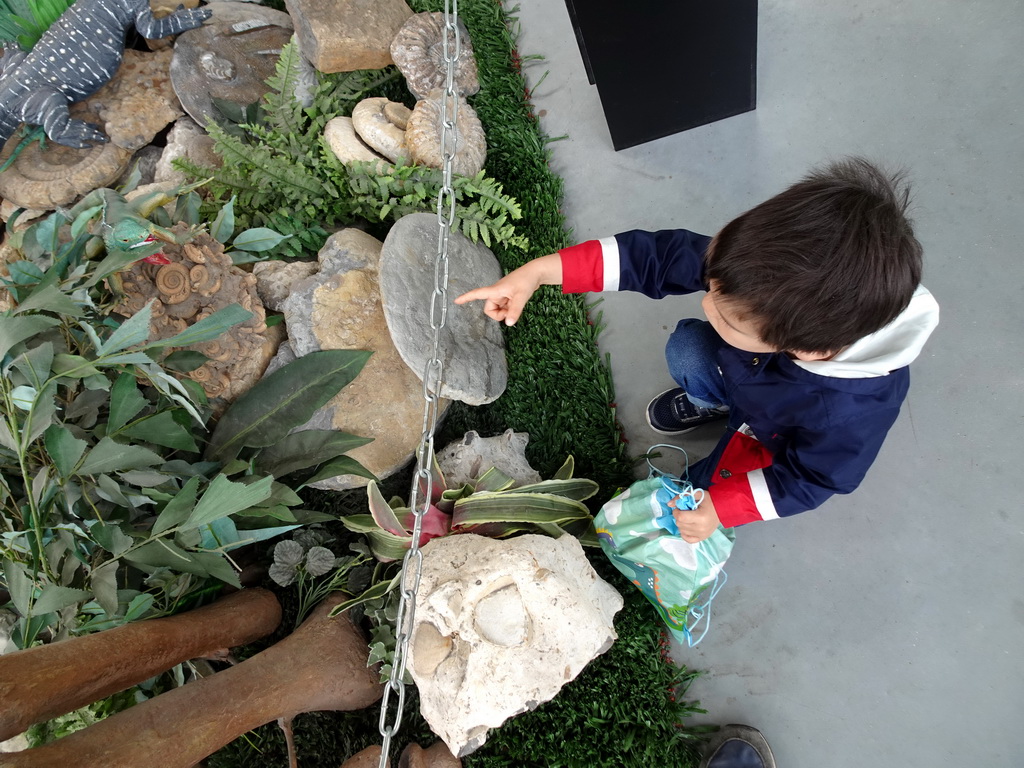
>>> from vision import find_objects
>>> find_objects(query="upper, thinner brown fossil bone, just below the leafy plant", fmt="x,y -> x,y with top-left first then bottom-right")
0,588 -> 281,741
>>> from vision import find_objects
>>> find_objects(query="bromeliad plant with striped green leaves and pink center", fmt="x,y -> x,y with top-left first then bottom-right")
341,456 -> 598,562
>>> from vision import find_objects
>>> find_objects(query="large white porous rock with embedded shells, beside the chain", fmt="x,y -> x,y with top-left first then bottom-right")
409,534 -> 623,758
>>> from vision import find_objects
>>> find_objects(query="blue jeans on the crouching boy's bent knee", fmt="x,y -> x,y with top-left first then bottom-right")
665,317 -> 729,408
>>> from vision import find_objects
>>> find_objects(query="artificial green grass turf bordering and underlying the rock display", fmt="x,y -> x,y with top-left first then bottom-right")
214,0 -> 712,768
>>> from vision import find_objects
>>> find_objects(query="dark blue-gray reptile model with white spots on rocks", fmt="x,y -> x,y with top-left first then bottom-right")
0,0 -> 212,148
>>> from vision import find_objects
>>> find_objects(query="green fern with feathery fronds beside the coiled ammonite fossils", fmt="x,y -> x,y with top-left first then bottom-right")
175,44 -> 526,257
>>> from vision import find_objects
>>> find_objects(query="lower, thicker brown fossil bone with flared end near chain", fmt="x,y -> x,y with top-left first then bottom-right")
0,593 -> 382,768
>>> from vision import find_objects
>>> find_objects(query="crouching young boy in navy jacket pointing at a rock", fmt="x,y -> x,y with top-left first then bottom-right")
455,159 -> 938,542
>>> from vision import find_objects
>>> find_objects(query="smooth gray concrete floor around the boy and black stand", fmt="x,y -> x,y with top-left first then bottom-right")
518,0 -> 1024,768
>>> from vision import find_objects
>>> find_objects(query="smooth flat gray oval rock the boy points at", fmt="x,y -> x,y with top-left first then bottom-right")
380,213 -> 508,406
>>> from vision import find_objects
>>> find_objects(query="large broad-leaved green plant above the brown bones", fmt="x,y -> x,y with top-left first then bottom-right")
0,204 -> 372,647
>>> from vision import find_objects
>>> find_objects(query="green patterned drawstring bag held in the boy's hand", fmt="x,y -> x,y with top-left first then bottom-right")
594,470 -> 735,647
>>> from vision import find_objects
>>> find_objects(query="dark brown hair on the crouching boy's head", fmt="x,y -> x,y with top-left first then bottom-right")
706,158 -> 922,352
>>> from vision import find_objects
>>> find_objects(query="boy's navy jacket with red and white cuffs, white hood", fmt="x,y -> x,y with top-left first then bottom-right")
560,229 -> 938,526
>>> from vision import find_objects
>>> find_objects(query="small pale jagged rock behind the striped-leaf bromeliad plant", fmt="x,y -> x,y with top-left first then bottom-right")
437,429 -> 541,487
